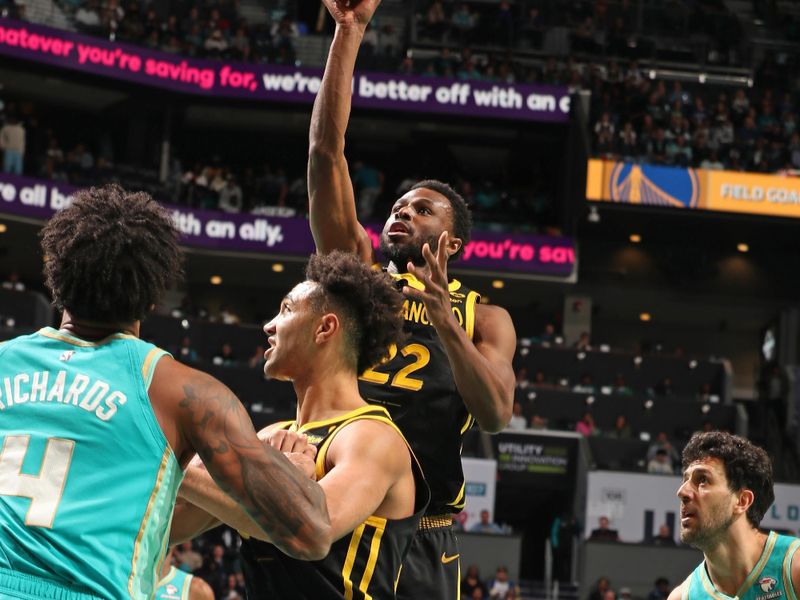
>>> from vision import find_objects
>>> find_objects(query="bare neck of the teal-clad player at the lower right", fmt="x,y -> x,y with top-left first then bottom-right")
703,519 -> 767,596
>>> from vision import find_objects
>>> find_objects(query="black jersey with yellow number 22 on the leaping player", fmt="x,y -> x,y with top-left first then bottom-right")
359,273 -> 480,514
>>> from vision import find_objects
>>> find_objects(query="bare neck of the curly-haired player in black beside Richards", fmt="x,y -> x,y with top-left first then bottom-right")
294,371 -> 366,425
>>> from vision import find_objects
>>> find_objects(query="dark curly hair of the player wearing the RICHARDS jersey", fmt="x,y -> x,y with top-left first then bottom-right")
40,185 -> 182,323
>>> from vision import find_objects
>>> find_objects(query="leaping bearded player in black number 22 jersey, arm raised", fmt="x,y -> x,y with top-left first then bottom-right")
308,0 -> 516,600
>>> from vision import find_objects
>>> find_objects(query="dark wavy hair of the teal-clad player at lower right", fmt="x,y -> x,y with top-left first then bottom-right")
681,431 -> 775,528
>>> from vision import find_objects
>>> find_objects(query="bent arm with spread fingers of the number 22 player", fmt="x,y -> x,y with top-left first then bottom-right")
403,231 -> 517,433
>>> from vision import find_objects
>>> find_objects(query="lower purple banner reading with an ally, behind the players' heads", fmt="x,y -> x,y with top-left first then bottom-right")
0,173 -> 575,279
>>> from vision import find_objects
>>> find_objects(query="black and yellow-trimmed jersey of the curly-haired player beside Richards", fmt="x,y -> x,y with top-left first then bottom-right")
241,406 -> 430,600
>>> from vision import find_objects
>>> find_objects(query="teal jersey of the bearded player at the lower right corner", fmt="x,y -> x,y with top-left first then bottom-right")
681,531 -> 800,600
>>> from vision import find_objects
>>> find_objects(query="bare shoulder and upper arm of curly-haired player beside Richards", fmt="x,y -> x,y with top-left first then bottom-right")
320,419 -> 414,541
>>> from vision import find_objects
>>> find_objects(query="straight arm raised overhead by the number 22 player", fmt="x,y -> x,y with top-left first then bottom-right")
308,0 -> 380,262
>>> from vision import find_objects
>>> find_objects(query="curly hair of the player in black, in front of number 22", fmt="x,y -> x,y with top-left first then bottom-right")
306,250 -> 403,373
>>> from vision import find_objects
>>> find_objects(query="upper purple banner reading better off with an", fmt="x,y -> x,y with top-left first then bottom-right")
0,19 -> 570,123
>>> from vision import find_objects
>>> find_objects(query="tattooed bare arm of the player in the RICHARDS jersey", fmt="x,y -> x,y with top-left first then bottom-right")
149,357 -> 331,560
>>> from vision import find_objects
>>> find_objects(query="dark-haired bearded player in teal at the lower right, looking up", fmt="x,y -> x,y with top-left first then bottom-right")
669,431 -> 800,600
